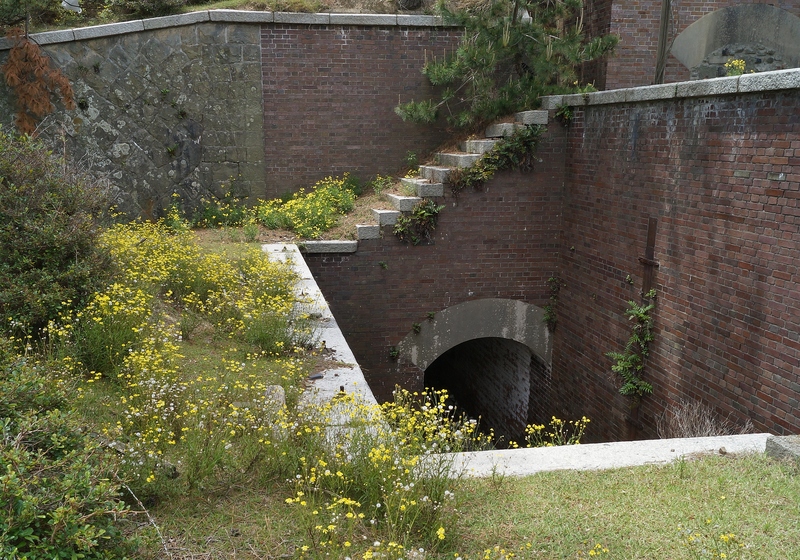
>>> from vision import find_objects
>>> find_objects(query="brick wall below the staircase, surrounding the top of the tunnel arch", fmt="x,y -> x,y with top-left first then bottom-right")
306,126 -> 564,399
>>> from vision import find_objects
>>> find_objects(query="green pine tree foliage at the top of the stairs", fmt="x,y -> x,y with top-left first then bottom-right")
395,0 -> 617,127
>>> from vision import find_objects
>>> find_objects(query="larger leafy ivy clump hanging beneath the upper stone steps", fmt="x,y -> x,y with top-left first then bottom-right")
449,125 -> 544,195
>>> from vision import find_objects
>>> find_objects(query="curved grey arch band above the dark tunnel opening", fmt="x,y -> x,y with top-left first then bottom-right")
397,298 -> 552,371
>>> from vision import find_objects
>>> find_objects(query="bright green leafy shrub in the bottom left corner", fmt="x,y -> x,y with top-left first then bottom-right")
0,339 -> 131,560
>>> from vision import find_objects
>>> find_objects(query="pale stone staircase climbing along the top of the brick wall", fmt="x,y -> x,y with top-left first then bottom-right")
303,110 -> 548,253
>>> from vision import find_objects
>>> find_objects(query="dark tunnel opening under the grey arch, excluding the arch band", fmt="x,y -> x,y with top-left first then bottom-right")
425,337 -> 550,443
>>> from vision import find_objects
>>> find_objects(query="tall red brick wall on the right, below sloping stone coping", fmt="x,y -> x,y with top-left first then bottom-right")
553,93 -> 800,439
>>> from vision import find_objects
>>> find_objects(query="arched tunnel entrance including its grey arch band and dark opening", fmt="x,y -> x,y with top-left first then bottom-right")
398,299 -> 551,442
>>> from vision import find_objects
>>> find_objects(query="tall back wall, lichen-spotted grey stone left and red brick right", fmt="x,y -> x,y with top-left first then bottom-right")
0,10 -> 460,218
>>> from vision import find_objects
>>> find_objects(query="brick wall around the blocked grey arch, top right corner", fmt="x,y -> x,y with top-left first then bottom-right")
600,0 -> 800,89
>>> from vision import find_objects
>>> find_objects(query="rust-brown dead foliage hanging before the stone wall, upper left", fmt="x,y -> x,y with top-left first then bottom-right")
0,27 -> 75,134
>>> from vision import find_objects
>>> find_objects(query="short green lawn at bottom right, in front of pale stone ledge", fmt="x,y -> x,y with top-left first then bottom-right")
450,455 -> 800,559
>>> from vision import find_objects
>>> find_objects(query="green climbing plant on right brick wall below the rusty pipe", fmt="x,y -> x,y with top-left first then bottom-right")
606,290 -> 656,408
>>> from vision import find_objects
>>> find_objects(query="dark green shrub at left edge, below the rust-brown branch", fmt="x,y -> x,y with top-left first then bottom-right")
0,130 -> 110,335
